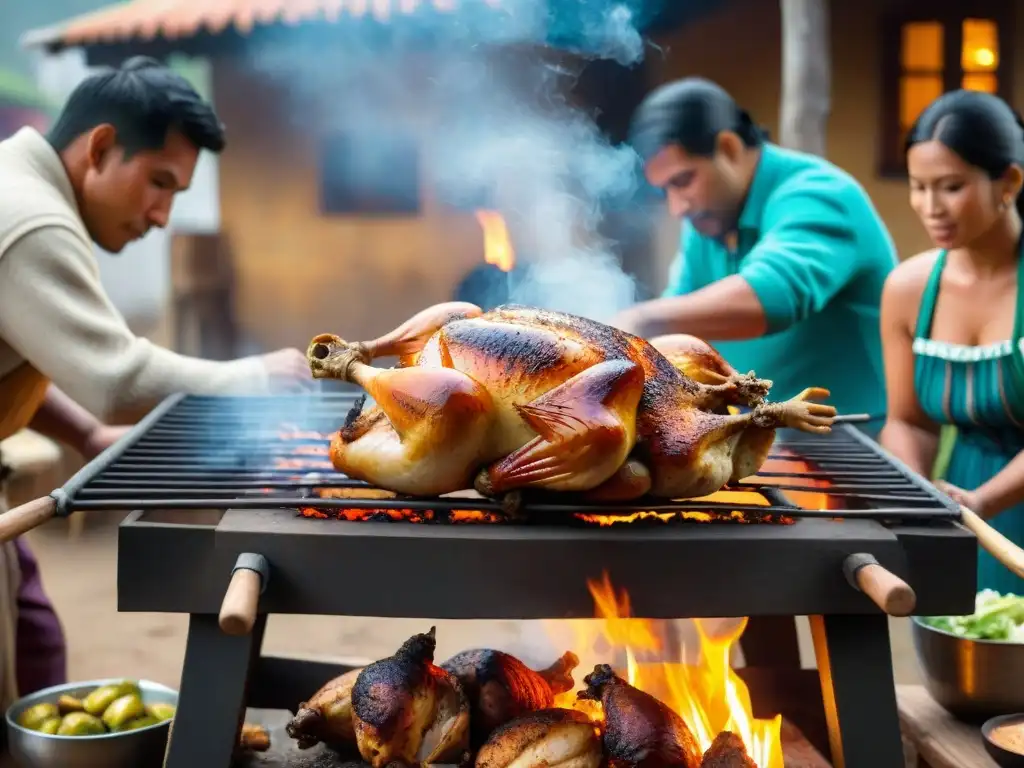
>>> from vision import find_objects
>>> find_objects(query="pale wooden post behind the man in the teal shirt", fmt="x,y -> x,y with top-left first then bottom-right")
779,0 -> 831,157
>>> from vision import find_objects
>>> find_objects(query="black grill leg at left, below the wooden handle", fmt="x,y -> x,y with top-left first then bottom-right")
164,613 -> 266,768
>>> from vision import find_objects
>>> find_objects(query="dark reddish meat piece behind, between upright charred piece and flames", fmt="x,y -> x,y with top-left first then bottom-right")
441,648 -> 580,746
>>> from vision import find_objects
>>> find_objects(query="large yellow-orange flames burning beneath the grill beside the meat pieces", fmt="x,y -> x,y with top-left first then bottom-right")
549,573 -> 783,768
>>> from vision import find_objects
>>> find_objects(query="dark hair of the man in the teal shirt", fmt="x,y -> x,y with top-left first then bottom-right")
630,78 -> 768,160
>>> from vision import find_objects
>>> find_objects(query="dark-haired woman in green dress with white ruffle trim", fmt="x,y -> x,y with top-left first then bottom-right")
880,91 -> 1024,595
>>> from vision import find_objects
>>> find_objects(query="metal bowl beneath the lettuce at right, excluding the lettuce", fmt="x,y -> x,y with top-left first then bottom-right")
910,617 -> 1024,722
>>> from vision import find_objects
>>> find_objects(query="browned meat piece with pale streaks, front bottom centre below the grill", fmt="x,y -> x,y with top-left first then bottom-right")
476,709 -> 604,768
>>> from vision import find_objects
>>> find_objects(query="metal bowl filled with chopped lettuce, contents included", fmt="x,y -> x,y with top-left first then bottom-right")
911,590 -> 1024,720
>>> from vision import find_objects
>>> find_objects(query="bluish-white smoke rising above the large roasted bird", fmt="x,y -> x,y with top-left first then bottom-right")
243,0 -> 659,322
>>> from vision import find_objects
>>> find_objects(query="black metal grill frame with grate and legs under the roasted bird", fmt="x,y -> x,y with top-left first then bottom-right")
96,393 -> 977,768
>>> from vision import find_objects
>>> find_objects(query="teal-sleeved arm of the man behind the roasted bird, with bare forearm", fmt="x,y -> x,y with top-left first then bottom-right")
614,175 -> 861,341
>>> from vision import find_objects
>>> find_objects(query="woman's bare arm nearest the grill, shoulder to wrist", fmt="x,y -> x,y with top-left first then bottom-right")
879,260 -> 939,478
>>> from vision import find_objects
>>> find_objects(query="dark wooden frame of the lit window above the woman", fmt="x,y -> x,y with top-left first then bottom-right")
878,0 -> 1015,179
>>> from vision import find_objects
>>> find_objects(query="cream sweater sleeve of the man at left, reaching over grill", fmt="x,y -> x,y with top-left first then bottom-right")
0,226 -> 268,421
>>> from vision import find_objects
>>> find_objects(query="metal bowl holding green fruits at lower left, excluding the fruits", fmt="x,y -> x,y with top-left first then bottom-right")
7,678 -> 178,768
